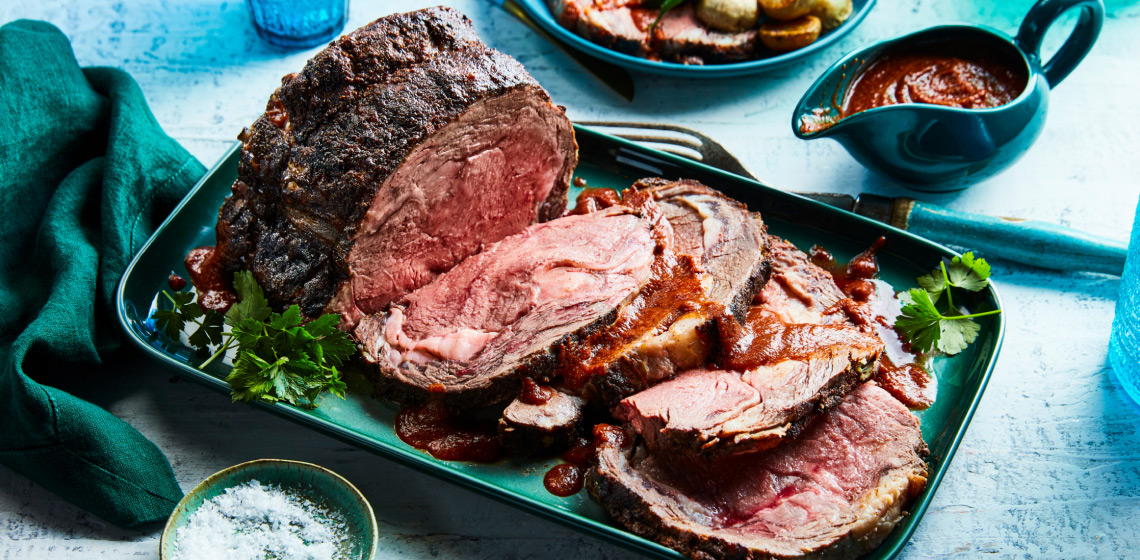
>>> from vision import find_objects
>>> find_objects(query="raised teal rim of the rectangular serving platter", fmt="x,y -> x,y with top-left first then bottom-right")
116,125 -> 1005,559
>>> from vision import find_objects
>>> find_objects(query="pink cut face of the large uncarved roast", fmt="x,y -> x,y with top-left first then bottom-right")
335,90 -> 575,323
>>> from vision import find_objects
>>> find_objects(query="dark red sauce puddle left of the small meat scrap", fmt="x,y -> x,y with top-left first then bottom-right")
396,404 -> 504,463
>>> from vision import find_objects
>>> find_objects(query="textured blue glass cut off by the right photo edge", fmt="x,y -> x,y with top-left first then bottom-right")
1108,197 -> 1140,404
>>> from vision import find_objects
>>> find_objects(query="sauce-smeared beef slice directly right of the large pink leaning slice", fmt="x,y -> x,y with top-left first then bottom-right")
560,179 -> 768,406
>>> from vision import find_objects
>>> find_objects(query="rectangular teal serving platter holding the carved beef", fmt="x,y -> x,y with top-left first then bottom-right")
117,127 -> 1005,559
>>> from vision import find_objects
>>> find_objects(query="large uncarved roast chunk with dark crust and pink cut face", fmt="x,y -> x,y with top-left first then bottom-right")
217,8 -> 577,324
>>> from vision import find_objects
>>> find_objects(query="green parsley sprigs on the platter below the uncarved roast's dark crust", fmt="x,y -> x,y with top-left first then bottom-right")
152,271 -> 356,408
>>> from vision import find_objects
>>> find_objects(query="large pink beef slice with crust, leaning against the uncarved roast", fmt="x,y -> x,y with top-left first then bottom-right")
356,205 -> 668,407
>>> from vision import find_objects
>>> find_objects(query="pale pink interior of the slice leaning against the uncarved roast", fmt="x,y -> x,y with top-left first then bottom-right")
384,209 -> 654,363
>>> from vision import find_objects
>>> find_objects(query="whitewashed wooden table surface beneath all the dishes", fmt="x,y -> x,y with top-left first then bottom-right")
0,0 -> 1140,560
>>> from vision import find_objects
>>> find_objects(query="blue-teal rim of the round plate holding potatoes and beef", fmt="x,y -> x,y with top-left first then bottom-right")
513,0 -> 877,78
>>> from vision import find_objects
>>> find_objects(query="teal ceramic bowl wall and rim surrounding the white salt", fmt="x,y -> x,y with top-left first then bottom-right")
158,458 -> 377,560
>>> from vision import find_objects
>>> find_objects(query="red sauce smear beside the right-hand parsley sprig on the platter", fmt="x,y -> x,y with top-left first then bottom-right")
808,237 -> 936,408
